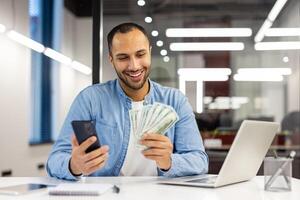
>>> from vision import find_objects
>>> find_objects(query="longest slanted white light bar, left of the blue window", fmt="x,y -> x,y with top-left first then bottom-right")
7,31 -> 45,53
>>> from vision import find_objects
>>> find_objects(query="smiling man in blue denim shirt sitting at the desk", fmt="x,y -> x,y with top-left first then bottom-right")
47,23 -> 208,180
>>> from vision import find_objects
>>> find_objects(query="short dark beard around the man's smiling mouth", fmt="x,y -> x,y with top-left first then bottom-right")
114,66 -> 150,90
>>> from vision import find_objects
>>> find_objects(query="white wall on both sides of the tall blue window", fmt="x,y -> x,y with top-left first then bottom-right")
0,0 -> 92,176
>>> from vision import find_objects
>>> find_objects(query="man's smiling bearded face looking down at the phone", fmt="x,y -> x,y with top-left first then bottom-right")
109,29 -> 151,90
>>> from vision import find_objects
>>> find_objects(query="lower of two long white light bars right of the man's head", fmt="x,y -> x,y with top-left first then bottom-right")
170,42 -> 245,51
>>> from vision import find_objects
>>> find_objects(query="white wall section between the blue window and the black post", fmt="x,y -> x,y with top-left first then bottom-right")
53,9 -> 92,138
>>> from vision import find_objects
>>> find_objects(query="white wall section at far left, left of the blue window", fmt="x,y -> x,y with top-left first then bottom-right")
0,0 -> 50,176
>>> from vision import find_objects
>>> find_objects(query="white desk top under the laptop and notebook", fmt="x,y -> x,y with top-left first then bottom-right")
0,176 -> 300,200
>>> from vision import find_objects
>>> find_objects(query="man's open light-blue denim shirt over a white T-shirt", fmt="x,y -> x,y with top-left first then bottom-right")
47,79 -> 208,180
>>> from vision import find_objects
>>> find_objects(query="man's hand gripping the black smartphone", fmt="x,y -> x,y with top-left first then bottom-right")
70,134 -> 109,175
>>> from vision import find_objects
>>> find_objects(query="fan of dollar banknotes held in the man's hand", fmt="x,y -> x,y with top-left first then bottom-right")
129,103 -> 179,148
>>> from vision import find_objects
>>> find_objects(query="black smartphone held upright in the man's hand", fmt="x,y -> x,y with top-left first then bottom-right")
71,120 -> 101,153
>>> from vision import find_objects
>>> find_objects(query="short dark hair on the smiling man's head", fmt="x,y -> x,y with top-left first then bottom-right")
107,22 -> 150,54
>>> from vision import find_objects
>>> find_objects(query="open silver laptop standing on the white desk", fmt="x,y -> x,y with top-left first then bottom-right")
159,120 -> 279,188
